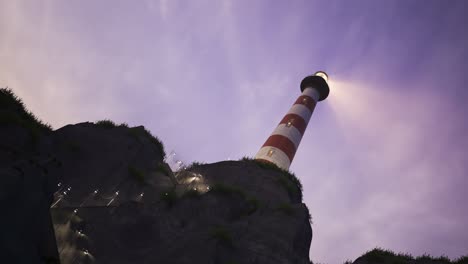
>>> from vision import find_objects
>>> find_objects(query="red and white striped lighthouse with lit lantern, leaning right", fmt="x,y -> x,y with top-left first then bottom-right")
255,71 -> 330,170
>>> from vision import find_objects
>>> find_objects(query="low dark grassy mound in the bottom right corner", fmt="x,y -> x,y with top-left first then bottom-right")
361,248 -> 468,264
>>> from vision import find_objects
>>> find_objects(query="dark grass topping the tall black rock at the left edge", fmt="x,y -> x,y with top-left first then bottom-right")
0,88 -> 52,131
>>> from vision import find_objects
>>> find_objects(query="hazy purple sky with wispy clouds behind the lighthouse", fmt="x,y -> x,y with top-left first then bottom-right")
0,0 -> 468,264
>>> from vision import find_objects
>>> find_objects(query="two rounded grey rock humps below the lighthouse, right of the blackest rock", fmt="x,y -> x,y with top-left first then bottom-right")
47,124 -> 312,263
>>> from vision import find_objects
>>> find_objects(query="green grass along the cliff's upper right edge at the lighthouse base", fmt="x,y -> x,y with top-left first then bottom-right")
242,157 -> 302,200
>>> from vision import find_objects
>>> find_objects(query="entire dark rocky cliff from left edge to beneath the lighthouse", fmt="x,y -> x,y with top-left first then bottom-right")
0,88 -> 312,264
